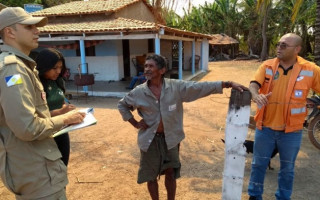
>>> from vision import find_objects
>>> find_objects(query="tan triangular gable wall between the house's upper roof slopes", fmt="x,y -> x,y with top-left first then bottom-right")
114,1 -> 155,22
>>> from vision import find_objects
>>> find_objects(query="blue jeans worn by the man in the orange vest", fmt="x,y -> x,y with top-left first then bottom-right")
248,128 -> 302,200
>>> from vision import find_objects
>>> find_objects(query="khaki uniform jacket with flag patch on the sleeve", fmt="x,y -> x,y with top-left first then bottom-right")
0,45 -> 68,199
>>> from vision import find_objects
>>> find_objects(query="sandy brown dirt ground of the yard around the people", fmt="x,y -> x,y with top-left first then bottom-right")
0,61 -> 320,200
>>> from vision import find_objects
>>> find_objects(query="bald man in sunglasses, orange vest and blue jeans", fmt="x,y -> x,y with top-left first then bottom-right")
248,33 -> 320,200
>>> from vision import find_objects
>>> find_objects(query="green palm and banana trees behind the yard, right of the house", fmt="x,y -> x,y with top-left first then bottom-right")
164,0 -> 317,60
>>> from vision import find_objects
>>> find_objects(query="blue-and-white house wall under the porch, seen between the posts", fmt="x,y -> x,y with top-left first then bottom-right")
53,40 -> 209,81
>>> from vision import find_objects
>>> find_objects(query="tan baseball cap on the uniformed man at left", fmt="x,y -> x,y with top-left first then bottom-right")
0,7 -> 48,30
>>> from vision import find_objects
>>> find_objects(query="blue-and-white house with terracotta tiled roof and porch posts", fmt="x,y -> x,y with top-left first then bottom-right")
32,0 -> 211,81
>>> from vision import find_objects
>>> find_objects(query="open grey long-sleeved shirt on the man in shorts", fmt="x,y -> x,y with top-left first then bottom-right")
118,78 -> 222,152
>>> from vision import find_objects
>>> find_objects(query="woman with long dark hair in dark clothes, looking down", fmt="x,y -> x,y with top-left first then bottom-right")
36,48 -> 75,166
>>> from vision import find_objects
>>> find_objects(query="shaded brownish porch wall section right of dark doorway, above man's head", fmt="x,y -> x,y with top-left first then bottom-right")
129,40 -> 148,76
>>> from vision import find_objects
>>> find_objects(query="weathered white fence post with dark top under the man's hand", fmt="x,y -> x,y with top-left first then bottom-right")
222,89 -> 251,200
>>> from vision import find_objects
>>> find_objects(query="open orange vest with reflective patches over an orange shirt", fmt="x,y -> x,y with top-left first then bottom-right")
254,56 -> 320,133
